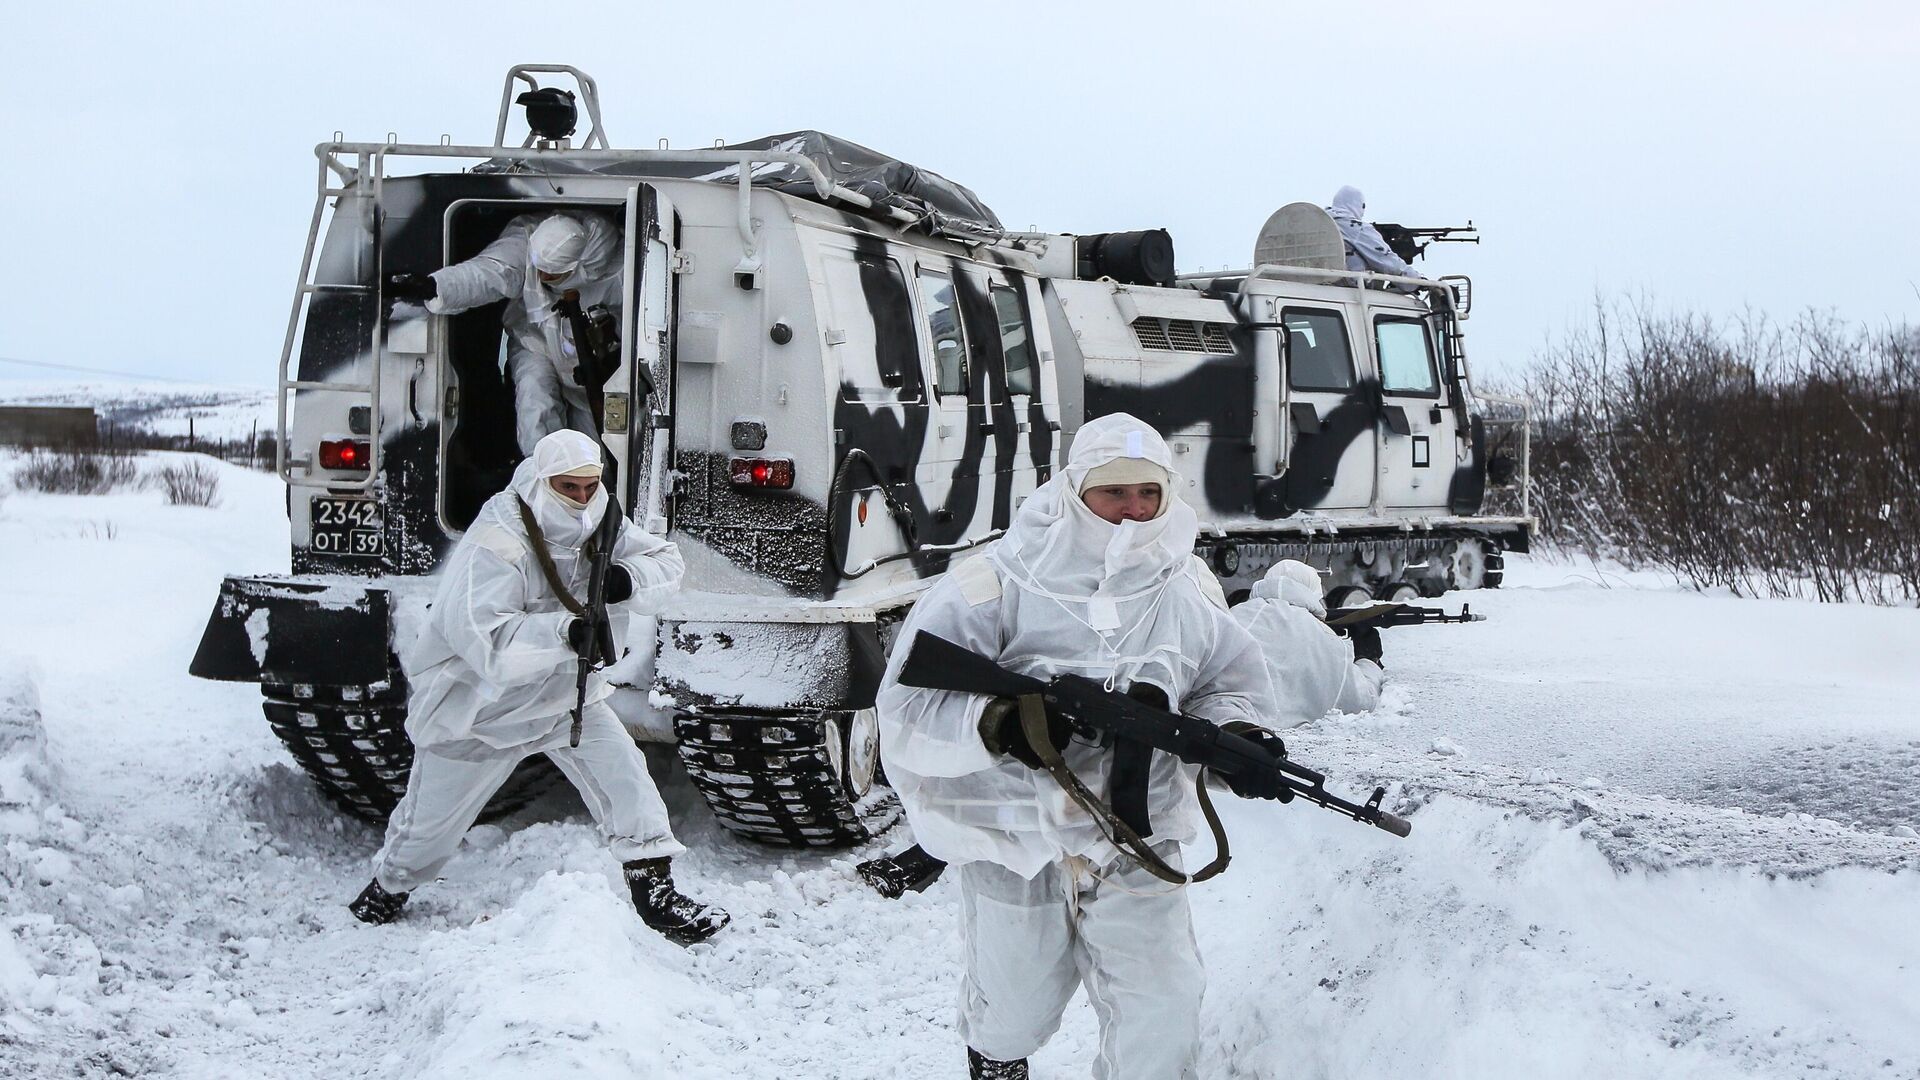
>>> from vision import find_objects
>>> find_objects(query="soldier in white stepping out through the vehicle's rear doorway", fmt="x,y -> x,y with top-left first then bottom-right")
386,211 -> 622,455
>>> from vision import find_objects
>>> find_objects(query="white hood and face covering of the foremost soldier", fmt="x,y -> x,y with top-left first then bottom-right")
991,413 -> 1200,667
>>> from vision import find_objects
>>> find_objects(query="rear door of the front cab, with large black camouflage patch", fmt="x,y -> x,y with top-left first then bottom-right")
1277,300 -> 1377,511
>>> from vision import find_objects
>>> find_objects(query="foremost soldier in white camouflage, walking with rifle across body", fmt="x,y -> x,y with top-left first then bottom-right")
877,413 -> 1281,1080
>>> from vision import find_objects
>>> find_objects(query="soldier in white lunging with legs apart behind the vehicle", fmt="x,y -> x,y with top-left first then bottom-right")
349,430 -> 728,944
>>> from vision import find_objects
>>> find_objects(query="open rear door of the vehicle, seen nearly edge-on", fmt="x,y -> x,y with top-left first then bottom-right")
622,184 -> 676,536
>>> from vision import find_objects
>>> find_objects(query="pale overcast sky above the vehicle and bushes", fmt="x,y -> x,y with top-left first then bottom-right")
0,0 -> 1920,384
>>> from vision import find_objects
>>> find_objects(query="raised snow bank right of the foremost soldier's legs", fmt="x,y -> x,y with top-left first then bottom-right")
1194,799 -> 1920,1080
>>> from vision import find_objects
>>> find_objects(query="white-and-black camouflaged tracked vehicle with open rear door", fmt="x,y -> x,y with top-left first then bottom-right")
192,67 -> 1532,846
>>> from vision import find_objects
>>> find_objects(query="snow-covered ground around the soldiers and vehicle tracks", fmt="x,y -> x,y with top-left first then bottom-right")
0,449 -> 1920,1080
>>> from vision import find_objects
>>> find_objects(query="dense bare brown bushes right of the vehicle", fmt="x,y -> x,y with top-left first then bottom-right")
1526,304 -> 1920,603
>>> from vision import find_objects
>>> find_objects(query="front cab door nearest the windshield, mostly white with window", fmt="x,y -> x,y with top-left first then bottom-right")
1371,311 -> 1459,511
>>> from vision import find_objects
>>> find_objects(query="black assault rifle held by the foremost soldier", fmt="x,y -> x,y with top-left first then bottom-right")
900,630 -> 1413,836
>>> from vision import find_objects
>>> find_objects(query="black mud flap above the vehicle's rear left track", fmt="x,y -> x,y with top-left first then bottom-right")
186,577 -> 392,686
